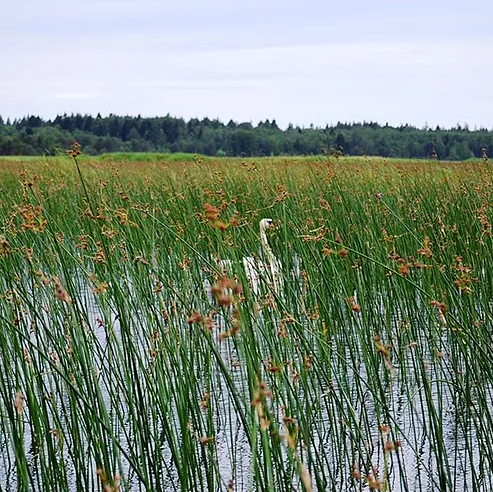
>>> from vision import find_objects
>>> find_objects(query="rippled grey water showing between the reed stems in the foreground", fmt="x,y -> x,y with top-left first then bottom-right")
0,268 -> 493,491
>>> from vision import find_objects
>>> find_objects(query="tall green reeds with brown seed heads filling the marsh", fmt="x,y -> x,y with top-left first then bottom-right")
0,154 -> 493,492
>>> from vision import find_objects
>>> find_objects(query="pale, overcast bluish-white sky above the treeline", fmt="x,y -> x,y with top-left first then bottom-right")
0,0 -> 493,129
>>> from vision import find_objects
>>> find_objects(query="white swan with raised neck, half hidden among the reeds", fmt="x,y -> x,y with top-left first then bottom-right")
243,219 -> 281,295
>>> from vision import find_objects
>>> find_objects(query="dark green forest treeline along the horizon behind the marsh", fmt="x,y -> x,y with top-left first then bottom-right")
0,114 -> 493,160
